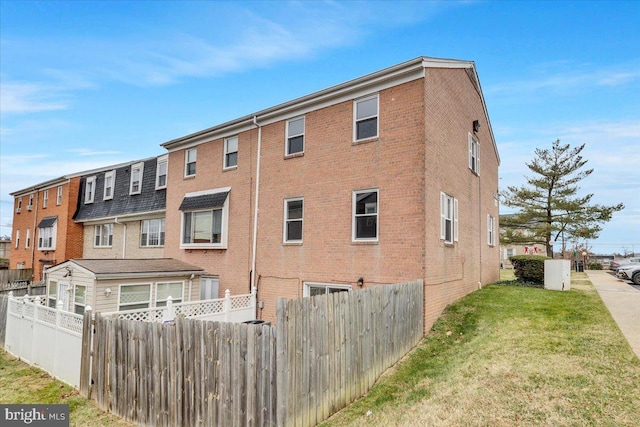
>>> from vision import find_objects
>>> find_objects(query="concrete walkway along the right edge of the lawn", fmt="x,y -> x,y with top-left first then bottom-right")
586,270 -> 640,358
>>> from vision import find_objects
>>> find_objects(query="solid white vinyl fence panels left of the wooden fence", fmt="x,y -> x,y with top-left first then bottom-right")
5,294 -> 83,388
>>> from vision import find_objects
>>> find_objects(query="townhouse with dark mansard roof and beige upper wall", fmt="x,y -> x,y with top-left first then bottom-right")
73,155 -> 167,259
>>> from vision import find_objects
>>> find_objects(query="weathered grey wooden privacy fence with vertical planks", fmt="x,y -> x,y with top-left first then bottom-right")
80,281 -> 423,426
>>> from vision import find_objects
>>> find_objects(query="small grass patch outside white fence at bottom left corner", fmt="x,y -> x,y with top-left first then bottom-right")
0,349 -> 133,427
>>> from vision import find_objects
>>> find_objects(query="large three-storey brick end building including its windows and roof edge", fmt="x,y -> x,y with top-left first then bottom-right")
163,57 -> 500,328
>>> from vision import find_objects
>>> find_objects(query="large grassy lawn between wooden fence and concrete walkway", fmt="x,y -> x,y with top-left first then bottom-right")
323,270 -> 640,427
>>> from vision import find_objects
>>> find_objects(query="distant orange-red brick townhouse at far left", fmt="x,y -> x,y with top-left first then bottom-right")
9,175 -> 83,282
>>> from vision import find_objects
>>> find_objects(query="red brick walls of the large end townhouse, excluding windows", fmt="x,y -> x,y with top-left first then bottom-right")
165,69 -> 499,328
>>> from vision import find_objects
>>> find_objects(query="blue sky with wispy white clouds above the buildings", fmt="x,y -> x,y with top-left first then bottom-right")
0,0 -> 640,253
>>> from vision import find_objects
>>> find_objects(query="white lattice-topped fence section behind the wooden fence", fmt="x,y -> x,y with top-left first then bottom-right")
101,289 -> 256,323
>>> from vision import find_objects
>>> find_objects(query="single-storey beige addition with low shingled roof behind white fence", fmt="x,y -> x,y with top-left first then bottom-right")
46,258 -> 202,314
